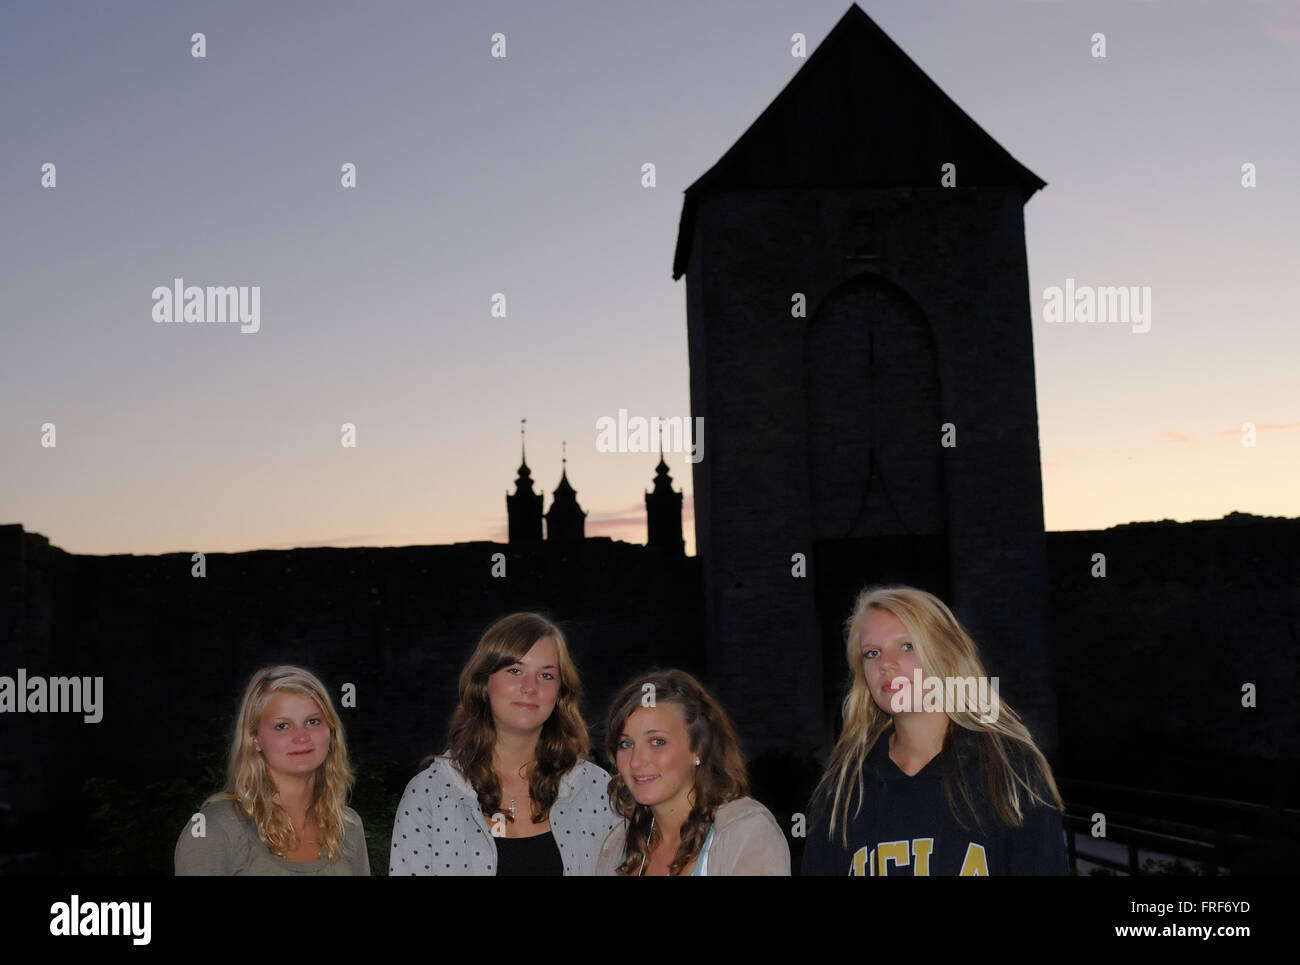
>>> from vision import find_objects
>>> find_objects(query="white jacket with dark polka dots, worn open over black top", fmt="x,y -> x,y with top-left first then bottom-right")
389,756 -> 621,875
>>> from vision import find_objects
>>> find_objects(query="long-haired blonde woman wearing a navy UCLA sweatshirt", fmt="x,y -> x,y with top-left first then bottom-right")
803,587 -> 1069,875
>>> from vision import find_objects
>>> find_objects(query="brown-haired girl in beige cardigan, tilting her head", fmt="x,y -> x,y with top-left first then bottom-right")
597,670 -> 790,877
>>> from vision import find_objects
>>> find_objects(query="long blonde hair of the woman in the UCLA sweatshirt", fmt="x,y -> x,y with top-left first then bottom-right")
814,587 -> 1061,847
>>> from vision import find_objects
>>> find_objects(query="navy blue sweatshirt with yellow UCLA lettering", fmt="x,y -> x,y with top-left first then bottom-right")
803,728 -> 1069,875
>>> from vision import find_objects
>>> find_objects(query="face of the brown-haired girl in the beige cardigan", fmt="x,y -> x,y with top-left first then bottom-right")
615,702 -> 696,814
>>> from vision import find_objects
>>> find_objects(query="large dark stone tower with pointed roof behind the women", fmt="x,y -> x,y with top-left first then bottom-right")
673,5 -> 1056,752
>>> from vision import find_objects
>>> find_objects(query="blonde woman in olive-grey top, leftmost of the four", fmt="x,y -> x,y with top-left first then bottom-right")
176,667 -> 371,875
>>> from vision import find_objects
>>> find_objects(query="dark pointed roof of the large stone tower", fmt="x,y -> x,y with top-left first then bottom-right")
672,4 -> 1047,278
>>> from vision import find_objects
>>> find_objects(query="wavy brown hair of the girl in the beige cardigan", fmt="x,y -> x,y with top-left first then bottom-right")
605,670 -> 749,875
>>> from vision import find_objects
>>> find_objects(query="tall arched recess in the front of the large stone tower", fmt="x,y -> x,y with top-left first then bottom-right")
803,267 -> 952,734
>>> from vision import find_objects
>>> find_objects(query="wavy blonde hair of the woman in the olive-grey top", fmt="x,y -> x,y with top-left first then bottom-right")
208,666 -> 352,861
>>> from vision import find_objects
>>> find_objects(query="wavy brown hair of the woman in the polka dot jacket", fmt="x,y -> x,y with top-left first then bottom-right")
447,613 -> 590,823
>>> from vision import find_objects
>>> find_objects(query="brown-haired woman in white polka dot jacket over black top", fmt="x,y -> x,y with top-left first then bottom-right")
389,613 -> 616,875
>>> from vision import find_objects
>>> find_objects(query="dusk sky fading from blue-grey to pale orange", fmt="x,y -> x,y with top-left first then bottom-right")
0,0 -> 1300,554
